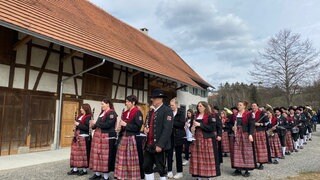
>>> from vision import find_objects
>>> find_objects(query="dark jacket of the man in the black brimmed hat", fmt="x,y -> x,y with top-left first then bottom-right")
149,104 -> 173,150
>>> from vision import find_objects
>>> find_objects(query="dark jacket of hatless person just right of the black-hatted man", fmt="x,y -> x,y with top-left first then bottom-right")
171,109 -> 186,146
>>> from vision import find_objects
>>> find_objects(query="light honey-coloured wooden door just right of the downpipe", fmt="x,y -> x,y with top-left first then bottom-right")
60,101 -> 80,147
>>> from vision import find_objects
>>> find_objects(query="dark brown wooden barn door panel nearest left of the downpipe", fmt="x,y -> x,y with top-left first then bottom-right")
28,95 -> 56,151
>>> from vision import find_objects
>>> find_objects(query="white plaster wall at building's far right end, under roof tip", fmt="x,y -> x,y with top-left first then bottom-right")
177,90 -> 208,114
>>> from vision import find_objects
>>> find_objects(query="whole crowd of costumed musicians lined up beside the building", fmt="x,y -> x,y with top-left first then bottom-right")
68,89 -> 318,180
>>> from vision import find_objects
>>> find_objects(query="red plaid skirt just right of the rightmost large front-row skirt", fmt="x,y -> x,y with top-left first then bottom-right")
254,131 -> 269,163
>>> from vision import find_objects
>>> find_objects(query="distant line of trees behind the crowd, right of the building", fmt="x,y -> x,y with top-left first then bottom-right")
208,80 -> 320,109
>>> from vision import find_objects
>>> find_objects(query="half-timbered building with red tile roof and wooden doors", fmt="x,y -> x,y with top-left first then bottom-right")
0,0 -> 210,155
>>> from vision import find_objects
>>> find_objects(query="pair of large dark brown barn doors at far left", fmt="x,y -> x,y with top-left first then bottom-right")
0,89 -> 56,156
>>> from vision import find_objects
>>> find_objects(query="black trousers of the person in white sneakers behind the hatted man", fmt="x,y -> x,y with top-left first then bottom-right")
166,145 -> 183,173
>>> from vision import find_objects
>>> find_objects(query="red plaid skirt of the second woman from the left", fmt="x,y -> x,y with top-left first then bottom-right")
89,129 -> 112,173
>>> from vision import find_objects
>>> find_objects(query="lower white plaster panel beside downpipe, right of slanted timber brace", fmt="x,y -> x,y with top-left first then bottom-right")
37,73 -> 58,92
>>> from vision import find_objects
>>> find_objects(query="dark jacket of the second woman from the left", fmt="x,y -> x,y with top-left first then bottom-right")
92,111 -> 118,137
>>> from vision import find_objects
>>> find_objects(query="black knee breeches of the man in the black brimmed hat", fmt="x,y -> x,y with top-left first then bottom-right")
143,150 -> 167,177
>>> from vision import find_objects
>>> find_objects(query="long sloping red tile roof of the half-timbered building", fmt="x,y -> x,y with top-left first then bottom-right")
0,0 -> 211,87
